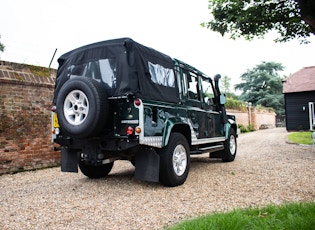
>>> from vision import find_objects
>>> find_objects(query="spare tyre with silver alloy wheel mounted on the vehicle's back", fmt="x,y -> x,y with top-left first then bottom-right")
56,77 -> 108,138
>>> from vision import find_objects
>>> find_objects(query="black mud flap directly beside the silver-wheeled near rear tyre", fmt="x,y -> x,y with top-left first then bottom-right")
135,149 -> 160,182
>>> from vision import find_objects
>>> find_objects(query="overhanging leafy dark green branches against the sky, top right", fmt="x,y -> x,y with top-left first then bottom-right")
201,0 -> 315,43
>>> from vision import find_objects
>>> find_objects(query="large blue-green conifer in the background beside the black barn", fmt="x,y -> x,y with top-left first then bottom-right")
235,62 -> 284,115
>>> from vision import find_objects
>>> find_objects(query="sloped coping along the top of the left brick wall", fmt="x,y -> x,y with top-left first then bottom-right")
0,61 -> 56,88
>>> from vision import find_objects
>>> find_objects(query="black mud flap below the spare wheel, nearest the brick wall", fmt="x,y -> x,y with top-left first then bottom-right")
61,148 -> 78,173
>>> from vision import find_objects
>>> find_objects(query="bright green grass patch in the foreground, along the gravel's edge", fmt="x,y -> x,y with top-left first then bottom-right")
167,202 -> 315,230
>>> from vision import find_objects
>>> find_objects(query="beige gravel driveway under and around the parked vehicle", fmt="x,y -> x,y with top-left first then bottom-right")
0,128 -> 315,229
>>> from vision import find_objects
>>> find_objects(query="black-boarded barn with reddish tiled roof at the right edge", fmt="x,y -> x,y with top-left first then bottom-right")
283,66 -> 315,131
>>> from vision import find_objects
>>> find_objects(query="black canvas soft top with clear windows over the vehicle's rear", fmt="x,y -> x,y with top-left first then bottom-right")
54,38 -> 179,102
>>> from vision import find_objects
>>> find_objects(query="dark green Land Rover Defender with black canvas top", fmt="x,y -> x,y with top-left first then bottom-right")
52,38 -> 237,186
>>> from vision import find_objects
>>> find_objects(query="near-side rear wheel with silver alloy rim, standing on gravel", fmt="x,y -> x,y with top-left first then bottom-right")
157,133 -> 190,187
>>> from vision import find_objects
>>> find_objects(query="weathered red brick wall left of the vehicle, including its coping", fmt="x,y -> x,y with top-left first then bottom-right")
0,62 -> 60,174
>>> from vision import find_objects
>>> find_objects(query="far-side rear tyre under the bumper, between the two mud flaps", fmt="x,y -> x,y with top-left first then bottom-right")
79,161 -> 114,179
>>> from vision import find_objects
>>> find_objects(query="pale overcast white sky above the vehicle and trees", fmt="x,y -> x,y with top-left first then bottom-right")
0,0 -> 315,89
